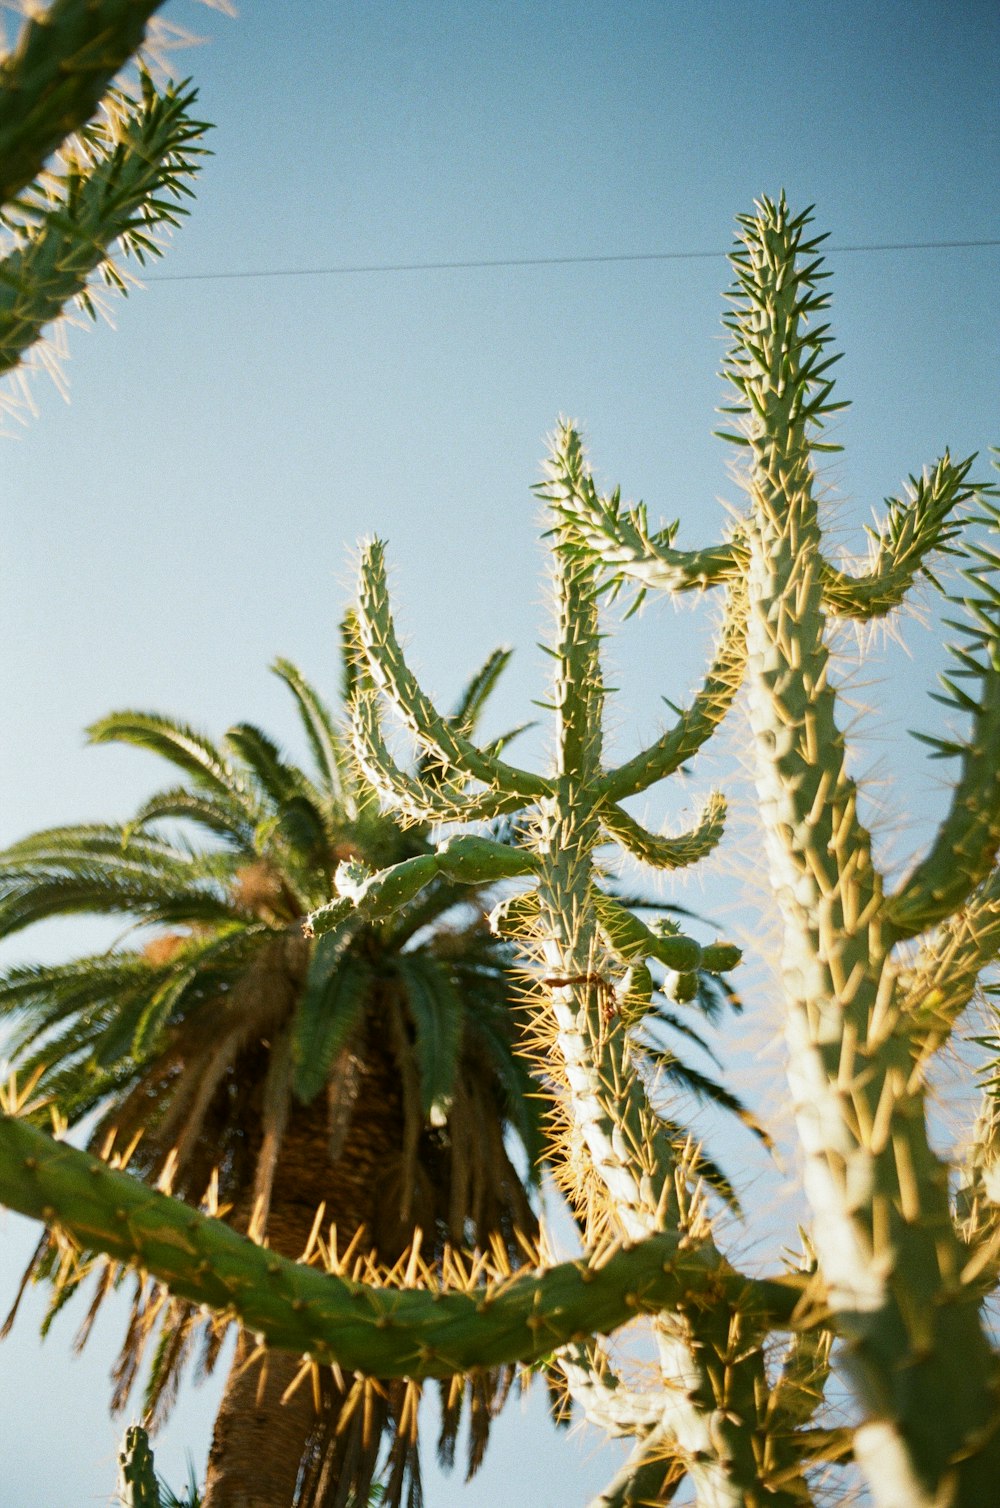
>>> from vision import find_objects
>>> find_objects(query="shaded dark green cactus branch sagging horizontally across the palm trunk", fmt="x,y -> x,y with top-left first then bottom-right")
0,1114 -> 801,1378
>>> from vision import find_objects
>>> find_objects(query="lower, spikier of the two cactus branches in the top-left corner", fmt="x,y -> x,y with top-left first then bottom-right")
0,77 -> 207,372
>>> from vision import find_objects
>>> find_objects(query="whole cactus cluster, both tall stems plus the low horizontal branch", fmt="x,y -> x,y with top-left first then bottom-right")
0,199 -> 1000,1508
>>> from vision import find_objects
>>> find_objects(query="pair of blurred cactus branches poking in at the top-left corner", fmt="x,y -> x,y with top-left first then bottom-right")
0,0 -> 207,407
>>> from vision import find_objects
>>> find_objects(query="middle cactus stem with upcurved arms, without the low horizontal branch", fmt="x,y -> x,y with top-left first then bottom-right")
340,425 -> 820,1508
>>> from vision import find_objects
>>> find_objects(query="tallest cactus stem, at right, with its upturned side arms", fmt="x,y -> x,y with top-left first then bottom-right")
567,198 -> 1000,1508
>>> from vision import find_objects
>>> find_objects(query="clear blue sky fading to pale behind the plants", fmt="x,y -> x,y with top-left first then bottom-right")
0,0 -> 1000,1508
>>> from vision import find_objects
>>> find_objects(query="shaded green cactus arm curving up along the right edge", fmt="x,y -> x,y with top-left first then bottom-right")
888,530 -> 1000,938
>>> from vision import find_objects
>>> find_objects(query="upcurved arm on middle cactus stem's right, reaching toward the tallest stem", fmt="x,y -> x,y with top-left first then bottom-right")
597,578 -> 747,801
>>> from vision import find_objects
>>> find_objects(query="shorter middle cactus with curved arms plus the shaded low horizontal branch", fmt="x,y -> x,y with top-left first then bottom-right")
0,425 -> 838,1508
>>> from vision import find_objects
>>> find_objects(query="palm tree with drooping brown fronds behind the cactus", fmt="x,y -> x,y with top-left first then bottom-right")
0,651 -> 540,1508
